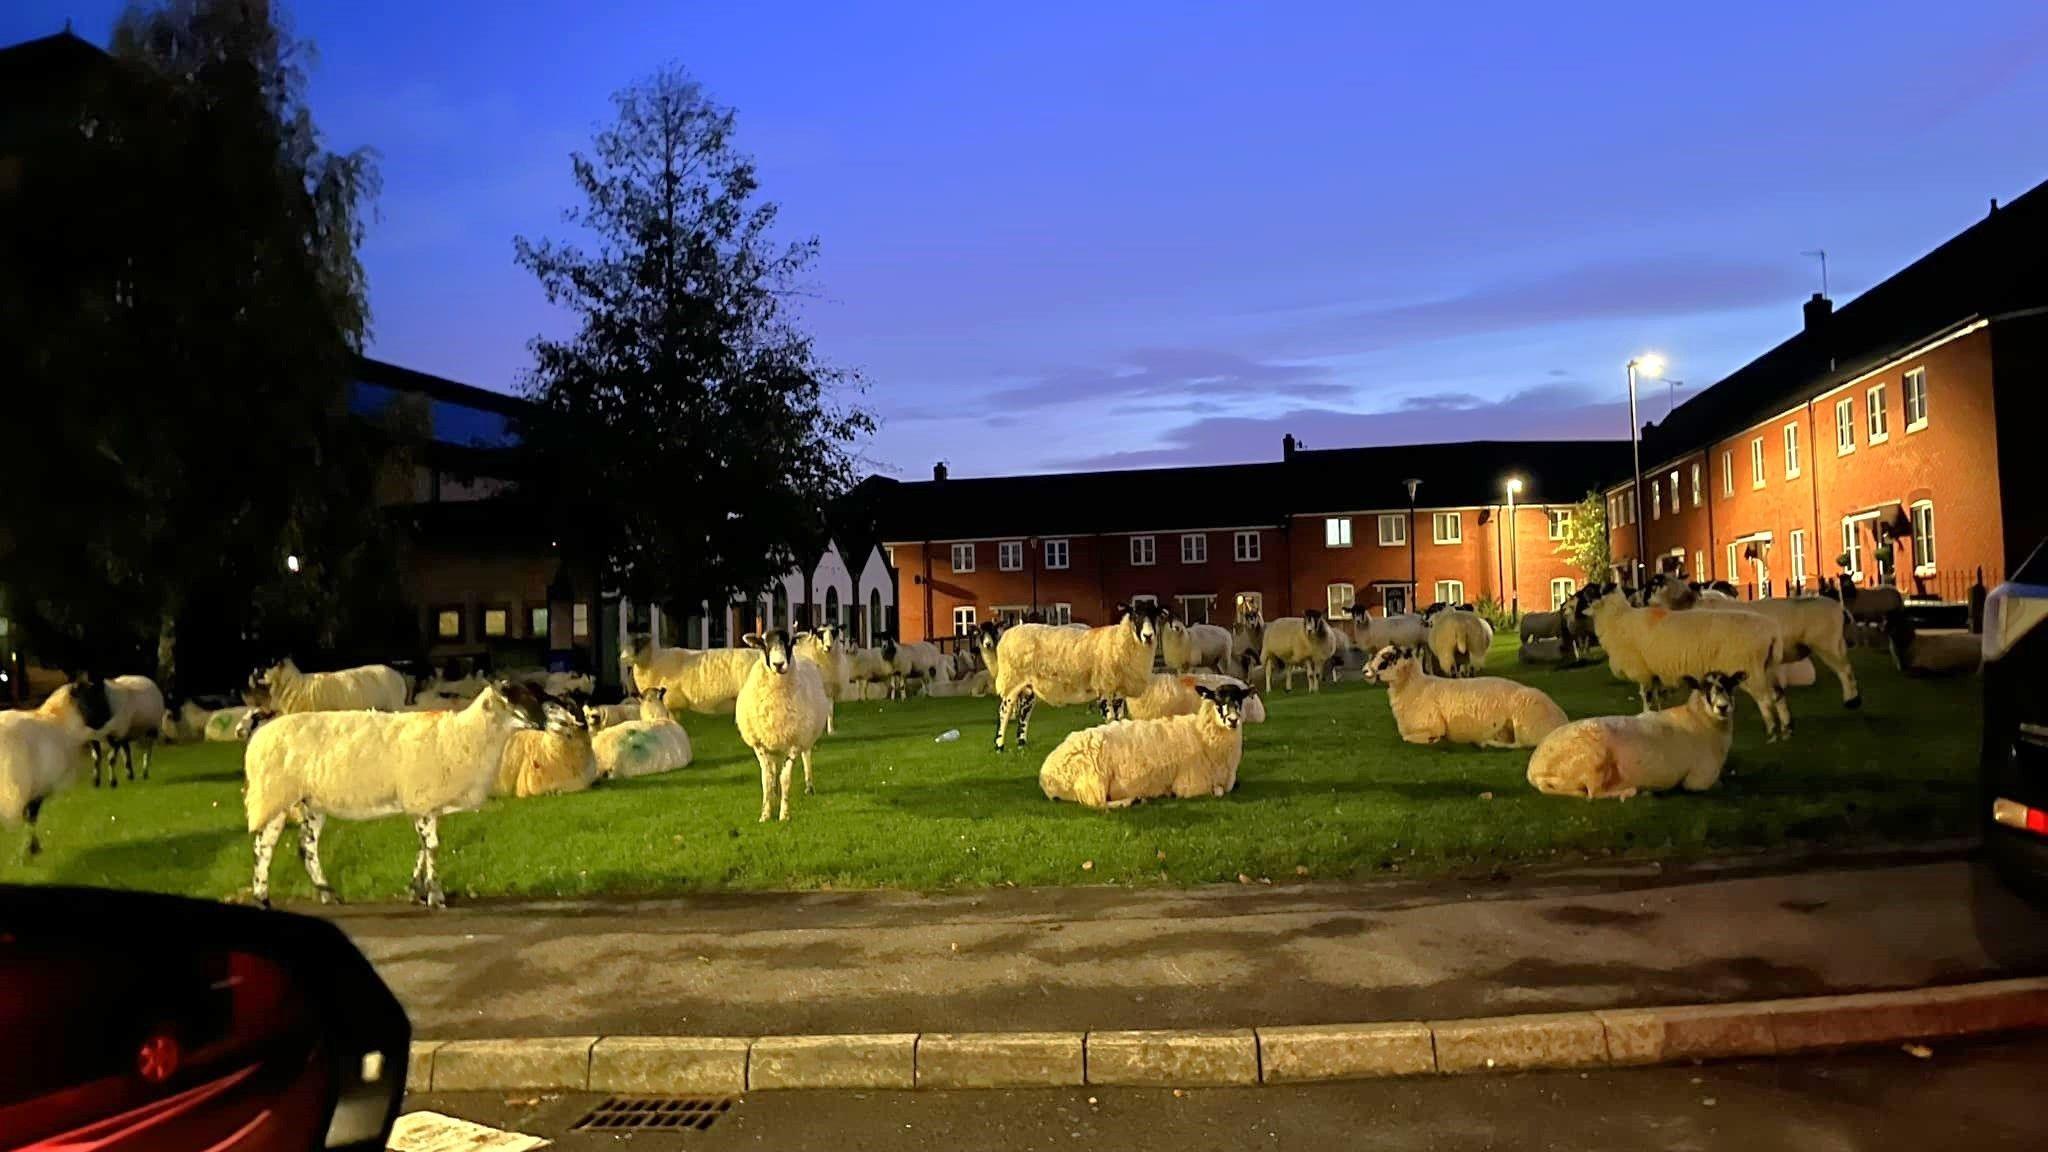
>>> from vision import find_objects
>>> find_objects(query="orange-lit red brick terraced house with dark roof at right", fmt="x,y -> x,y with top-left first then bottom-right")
1606,189 -> 2048,601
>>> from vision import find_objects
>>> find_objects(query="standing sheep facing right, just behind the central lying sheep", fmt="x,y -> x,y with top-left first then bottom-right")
995,603 -> 1159,752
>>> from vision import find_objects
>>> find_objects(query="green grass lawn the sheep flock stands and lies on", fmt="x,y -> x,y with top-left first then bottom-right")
0,637 -> 1978,902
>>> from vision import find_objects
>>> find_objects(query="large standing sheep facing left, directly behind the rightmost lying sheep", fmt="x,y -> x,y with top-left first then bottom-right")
1587,588 -> 1792,740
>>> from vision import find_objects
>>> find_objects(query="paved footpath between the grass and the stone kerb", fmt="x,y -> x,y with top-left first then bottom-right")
336,844 -> 2048,1039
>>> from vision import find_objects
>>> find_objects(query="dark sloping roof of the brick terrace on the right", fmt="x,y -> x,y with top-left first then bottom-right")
1642,184 -> 2048,465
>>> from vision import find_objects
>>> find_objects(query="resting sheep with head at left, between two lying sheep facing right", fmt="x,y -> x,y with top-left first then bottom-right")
1366,648 -> 1565,748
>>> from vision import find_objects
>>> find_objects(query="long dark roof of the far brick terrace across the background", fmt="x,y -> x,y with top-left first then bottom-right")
862,441 -> 1628,541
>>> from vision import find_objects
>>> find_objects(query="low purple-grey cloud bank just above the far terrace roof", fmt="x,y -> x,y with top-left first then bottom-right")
1059,383 -> 1628,469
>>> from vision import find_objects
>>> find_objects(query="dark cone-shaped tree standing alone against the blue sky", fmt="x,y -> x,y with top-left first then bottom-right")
516,68 -> 874,627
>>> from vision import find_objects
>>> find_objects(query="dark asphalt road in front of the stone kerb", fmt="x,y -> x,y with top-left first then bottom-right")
408,1037 -> 2048,1152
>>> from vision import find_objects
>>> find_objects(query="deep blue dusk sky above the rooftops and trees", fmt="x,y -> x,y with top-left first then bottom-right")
16,0 -> 2048,476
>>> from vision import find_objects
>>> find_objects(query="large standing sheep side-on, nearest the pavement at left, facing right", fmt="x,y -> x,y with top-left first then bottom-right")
242,683 -> 547,908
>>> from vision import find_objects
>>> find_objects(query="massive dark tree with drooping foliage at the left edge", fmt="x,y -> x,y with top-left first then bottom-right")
0,0 -> 379,681
